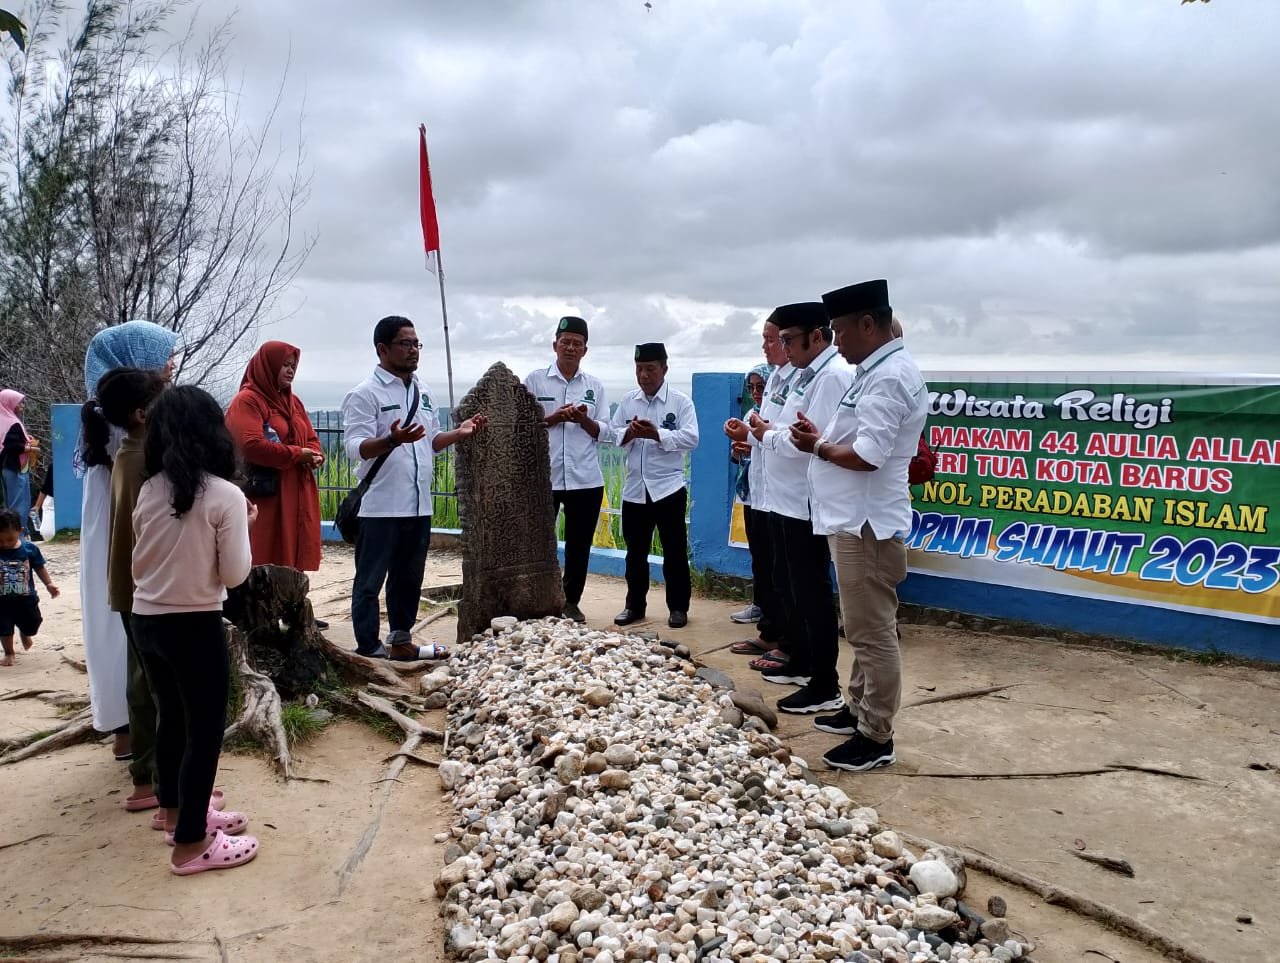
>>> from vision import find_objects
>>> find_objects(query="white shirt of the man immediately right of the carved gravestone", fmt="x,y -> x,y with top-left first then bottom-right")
525,361 -> 609,492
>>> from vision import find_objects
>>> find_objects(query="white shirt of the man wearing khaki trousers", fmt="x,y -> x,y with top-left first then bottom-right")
809,341 -> 929,539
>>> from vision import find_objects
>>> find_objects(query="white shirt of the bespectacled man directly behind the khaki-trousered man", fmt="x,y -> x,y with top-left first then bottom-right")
760,346 -> 854,520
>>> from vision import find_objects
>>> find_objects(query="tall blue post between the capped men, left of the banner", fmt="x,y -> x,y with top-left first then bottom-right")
689,373 -> 751,578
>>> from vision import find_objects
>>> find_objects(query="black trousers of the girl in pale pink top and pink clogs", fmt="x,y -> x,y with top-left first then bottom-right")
133,612 -> 230,843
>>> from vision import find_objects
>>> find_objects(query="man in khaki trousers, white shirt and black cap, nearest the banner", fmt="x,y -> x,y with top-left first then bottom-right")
791,274 -> 929,772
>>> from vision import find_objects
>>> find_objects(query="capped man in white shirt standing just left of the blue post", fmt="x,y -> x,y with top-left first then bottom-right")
609,342 -> 698,629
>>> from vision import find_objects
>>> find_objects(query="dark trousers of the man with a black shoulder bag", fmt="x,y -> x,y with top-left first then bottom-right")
351,515 -> 431,654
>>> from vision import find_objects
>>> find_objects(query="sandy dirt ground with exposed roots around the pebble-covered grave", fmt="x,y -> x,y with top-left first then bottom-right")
0,543 -> 1280,963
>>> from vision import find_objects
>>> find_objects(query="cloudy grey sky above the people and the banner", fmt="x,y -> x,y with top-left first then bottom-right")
197,0 -> 1280,406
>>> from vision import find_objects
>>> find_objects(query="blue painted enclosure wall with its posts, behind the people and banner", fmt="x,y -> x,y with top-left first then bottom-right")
45,373 -> 1280,662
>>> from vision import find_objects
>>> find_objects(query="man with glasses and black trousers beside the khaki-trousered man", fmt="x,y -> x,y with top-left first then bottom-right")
726,301 -> 852,713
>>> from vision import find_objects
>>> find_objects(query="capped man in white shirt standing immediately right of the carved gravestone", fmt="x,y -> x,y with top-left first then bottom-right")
525,316 -> 609,622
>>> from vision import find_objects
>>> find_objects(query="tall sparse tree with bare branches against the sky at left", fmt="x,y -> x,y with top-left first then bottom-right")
0,0 -> 315,424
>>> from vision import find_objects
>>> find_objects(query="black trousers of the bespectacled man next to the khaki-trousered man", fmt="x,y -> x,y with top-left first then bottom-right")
769,514 -> 840,694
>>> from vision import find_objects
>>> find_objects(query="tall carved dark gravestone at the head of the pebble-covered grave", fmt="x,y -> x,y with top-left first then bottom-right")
453,361 -> 564,642
